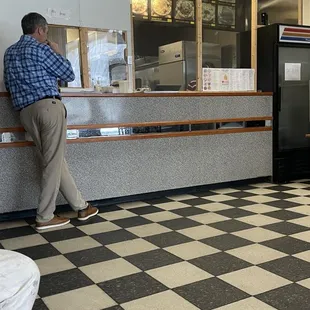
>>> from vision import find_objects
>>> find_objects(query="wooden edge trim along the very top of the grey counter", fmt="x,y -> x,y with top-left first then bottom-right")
0,92 -> 273,98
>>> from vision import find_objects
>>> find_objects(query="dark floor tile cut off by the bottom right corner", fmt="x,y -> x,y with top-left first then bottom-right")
256,284 -> 310,310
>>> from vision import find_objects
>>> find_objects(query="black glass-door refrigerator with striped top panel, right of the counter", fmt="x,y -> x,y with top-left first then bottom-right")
240,24 -> 310,183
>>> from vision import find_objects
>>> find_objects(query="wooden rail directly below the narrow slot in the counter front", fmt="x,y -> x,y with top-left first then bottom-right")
0,127 -> 272,148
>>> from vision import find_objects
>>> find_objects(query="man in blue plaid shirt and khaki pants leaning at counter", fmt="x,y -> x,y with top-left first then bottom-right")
4,13 -> 98,230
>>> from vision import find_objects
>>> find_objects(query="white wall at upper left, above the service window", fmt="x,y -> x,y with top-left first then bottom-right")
0,0 -> 132,91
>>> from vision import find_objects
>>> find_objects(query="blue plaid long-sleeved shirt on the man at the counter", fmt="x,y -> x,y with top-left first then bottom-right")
4,35 -> 75,111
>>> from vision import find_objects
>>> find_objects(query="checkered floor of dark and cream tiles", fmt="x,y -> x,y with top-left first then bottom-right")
0,181 -> 310,310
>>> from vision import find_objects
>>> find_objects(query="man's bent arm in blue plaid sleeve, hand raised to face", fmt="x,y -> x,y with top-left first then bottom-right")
42,42 -> 75,82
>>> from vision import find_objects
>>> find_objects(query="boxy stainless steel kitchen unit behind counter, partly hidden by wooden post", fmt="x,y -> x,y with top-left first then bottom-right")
159,41 -> 221,89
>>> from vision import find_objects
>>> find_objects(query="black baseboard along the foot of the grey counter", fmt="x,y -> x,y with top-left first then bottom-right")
0,177 -> 271,222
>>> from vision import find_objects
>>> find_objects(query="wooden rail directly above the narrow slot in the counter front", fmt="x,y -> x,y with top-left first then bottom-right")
0,116 -> 272,133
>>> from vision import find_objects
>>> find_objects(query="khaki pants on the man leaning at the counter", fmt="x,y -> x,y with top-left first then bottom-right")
20,99 -> 87,223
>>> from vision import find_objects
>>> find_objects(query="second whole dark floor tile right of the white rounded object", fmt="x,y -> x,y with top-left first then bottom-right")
98,272 -> 167,304
